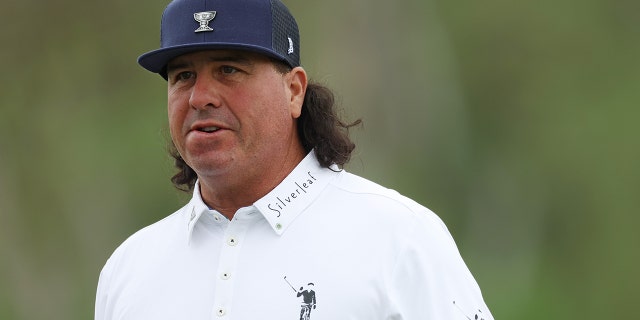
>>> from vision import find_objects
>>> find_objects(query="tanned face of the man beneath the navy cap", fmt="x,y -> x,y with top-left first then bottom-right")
167,50 -> 306,183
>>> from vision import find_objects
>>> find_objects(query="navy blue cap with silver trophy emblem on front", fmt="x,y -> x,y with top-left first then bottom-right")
138,0 -> 300,77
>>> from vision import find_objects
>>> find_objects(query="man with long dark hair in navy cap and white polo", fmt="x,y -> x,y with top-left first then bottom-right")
95,0 -> 492,320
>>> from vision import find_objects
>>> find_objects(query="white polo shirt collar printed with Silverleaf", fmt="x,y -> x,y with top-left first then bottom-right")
186,151 -> 340,238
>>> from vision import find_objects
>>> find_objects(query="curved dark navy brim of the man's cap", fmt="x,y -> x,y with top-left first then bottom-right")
138,43 -> 293,78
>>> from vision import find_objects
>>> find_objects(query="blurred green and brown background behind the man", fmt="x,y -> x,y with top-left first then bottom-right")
0,0 -> 640,320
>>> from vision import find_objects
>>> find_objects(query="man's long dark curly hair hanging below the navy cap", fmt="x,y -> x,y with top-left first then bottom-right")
169,69 -> 362,191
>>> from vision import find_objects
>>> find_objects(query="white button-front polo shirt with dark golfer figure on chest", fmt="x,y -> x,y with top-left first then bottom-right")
95,152 -> 493,320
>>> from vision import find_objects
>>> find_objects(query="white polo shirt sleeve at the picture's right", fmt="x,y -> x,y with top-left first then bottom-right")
389,212 -> 493,320
